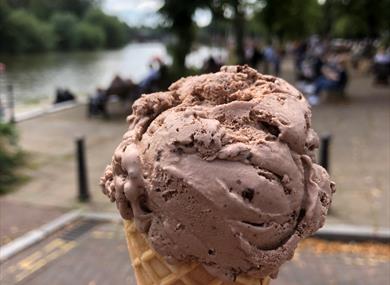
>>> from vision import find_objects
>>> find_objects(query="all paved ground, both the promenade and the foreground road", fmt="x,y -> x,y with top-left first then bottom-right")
0,65 -> 390,285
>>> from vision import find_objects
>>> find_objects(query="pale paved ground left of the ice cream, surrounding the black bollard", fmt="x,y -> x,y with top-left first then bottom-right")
7,102 -> 129,211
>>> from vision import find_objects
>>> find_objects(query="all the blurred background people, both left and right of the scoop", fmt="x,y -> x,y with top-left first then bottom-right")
68,36 -> 390,116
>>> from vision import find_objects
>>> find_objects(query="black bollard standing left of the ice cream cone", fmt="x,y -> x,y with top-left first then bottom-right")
76,137 -> 90,202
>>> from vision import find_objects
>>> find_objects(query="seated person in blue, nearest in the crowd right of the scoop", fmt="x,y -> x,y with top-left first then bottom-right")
308,56 -> 348,105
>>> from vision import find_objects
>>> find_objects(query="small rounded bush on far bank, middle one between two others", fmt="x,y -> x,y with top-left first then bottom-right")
76,22 -> 106,50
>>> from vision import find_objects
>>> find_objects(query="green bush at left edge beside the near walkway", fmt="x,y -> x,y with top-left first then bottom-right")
0,122 -> 23,194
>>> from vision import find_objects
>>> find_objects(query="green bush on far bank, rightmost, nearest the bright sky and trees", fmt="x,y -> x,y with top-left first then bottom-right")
85,9 -> 128,48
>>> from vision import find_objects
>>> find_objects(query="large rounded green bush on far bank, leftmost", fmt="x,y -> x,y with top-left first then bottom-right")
4,10 -> 56,52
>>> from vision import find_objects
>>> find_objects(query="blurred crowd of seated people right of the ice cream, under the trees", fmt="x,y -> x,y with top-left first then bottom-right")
236,36 -> 390,105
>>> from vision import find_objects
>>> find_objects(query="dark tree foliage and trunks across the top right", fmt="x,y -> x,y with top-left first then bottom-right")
160,0 -> 390,74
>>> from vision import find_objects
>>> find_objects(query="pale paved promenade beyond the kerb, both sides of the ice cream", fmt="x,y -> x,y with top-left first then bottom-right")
1,58 -> 390,247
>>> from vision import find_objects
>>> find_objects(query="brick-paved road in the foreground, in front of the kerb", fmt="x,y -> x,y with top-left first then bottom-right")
0,220 -> 390,285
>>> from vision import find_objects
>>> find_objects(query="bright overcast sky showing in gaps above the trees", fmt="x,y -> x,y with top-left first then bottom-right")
102,0 -> 211,26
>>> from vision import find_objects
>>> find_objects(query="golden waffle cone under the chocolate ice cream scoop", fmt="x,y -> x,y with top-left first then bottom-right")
124,220 -> 270,285
